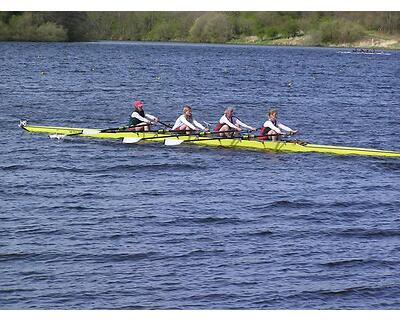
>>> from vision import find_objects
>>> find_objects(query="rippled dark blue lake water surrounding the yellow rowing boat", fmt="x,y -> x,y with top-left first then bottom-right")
0,42 -> 400,309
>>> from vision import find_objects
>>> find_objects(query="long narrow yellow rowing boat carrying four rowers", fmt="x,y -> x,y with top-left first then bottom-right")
20,123 -> 400,157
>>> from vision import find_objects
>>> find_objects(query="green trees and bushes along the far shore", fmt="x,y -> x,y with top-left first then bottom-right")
0,11 -> 400,45
